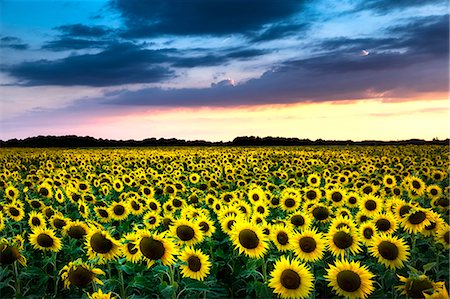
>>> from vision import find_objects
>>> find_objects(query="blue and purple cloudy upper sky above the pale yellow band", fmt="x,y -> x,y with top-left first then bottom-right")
0,0 -> 449,141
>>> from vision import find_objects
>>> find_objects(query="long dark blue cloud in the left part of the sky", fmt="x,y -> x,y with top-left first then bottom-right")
4,43 -> 174,86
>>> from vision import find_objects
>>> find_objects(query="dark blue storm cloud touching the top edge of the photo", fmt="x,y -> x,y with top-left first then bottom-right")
111,0 -> 302,37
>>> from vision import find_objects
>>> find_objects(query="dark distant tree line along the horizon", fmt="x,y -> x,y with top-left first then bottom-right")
0,135 -> 449,148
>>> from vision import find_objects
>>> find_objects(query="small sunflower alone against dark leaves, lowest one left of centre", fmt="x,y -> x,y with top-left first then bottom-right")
179,247 -> 211,280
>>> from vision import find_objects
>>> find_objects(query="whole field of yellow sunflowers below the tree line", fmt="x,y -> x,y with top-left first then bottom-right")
0,146 -> 450,298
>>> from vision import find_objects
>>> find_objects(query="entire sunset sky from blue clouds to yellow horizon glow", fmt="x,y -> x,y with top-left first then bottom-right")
0,0 -> 450,141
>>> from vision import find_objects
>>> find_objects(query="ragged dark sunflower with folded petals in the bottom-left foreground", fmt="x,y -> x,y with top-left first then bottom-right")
59,259 -> 105,289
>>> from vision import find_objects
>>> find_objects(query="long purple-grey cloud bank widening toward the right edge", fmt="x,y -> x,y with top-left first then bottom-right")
100,16 -> 449,106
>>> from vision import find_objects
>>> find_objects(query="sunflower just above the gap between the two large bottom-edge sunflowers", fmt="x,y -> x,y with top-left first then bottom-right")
292,229 -> 325,262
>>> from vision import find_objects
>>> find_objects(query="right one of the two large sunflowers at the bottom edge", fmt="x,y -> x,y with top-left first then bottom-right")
324,260 -> 375,299
